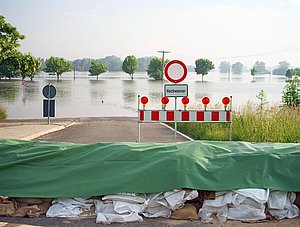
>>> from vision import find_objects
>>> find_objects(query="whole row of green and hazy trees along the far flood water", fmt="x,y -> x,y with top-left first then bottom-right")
0,15 -> 297,81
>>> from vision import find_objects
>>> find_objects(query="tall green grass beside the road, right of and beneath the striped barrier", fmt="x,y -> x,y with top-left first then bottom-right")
177,104 -> 300,143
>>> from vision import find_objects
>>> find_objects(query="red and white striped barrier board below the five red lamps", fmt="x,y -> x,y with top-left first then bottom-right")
138,110 -> 231,123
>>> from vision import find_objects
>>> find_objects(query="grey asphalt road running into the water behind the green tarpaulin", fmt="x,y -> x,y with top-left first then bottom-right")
34,118 -> 188,144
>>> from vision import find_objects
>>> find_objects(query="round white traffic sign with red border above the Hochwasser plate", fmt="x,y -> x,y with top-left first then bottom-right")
165,60 -> 187,83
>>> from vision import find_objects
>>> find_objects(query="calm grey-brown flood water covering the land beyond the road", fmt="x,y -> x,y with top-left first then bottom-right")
0,72 -> 286,119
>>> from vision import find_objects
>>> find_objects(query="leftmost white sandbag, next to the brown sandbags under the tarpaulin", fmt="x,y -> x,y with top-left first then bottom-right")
46,198 -> 94,217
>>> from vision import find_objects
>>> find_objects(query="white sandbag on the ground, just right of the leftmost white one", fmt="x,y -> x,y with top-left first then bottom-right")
95,200 -> 143,224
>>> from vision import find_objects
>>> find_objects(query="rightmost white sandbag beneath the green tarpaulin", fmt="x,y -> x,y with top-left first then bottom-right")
268,191 -> 299,219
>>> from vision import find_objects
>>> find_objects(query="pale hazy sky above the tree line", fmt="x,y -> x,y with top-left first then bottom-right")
0,0 -> 300,67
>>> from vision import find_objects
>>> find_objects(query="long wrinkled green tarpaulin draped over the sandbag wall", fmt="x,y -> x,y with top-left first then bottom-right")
0,140 -> 300,198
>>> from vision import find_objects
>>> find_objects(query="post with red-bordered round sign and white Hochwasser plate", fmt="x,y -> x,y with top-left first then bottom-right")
164,60 -> 188,141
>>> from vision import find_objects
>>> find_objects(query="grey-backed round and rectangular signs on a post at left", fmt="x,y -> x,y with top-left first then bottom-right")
42,84 -> 56,125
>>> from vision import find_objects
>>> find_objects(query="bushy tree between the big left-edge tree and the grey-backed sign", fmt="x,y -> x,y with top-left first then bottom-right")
19,53 -> 41,80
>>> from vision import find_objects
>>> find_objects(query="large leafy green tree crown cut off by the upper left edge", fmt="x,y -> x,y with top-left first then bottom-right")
0,15 -> 25,66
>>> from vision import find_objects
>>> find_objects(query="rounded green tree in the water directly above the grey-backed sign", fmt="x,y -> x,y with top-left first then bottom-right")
44,57 -> 72,80
